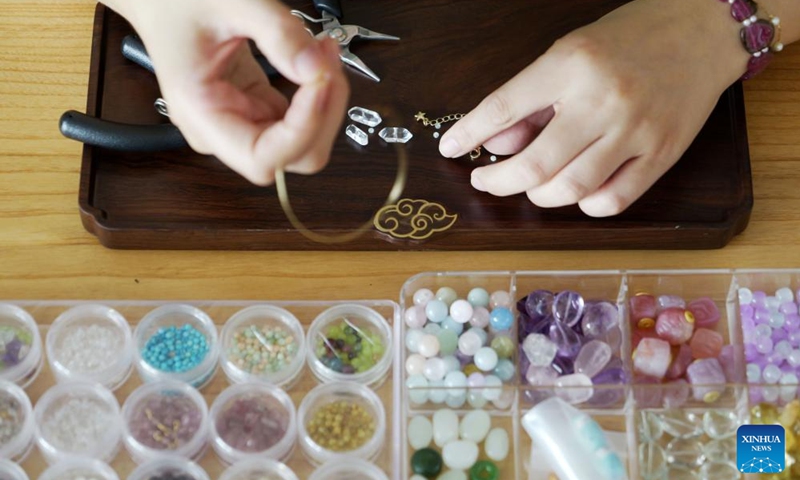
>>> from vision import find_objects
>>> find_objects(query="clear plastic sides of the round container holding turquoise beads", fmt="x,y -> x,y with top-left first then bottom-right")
133,305 -> 219,388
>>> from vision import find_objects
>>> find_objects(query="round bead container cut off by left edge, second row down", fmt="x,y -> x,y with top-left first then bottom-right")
0,380 -> 36,462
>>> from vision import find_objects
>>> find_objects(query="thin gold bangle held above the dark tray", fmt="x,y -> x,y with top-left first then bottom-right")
275,144 -> 408,245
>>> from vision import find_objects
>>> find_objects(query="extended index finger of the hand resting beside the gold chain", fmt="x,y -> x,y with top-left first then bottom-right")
439,55 -> 559,158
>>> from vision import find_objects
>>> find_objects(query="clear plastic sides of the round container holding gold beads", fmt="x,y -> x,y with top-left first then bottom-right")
297,382 -> 386,465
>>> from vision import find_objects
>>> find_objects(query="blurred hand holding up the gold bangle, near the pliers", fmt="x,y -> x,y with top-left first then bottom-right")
107,0 -> 349,185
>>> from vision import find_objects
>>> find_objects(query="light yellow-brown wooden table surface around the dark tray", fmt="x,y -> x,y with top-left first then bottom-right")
0,0 -> 800,476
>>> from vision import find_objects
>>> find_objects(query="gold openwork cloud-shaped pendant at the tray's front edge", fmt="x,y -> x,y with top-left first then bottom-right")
374,198 -> 458,240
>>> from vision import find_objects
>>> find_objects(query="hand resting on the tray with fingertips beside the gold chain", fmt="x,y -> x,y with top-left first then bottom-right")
439,0 -> 749,217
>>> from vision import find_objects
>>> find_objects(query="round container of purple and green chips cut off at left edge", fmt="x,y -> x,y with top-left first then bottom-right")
0,303 -> 44,388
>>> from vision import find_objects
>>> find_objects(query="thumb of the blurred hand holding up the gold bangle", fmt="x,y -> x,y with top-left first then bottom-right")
223,0 -> 338,85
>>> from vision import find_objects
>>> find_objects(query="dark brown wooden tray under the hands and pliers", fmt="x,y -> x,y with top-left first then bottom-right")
80,0 -> 753,250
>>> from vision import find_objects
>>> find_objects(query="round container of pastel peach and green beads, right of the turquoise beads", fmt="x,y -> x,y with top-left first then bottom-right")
220,305 -> 306,388
